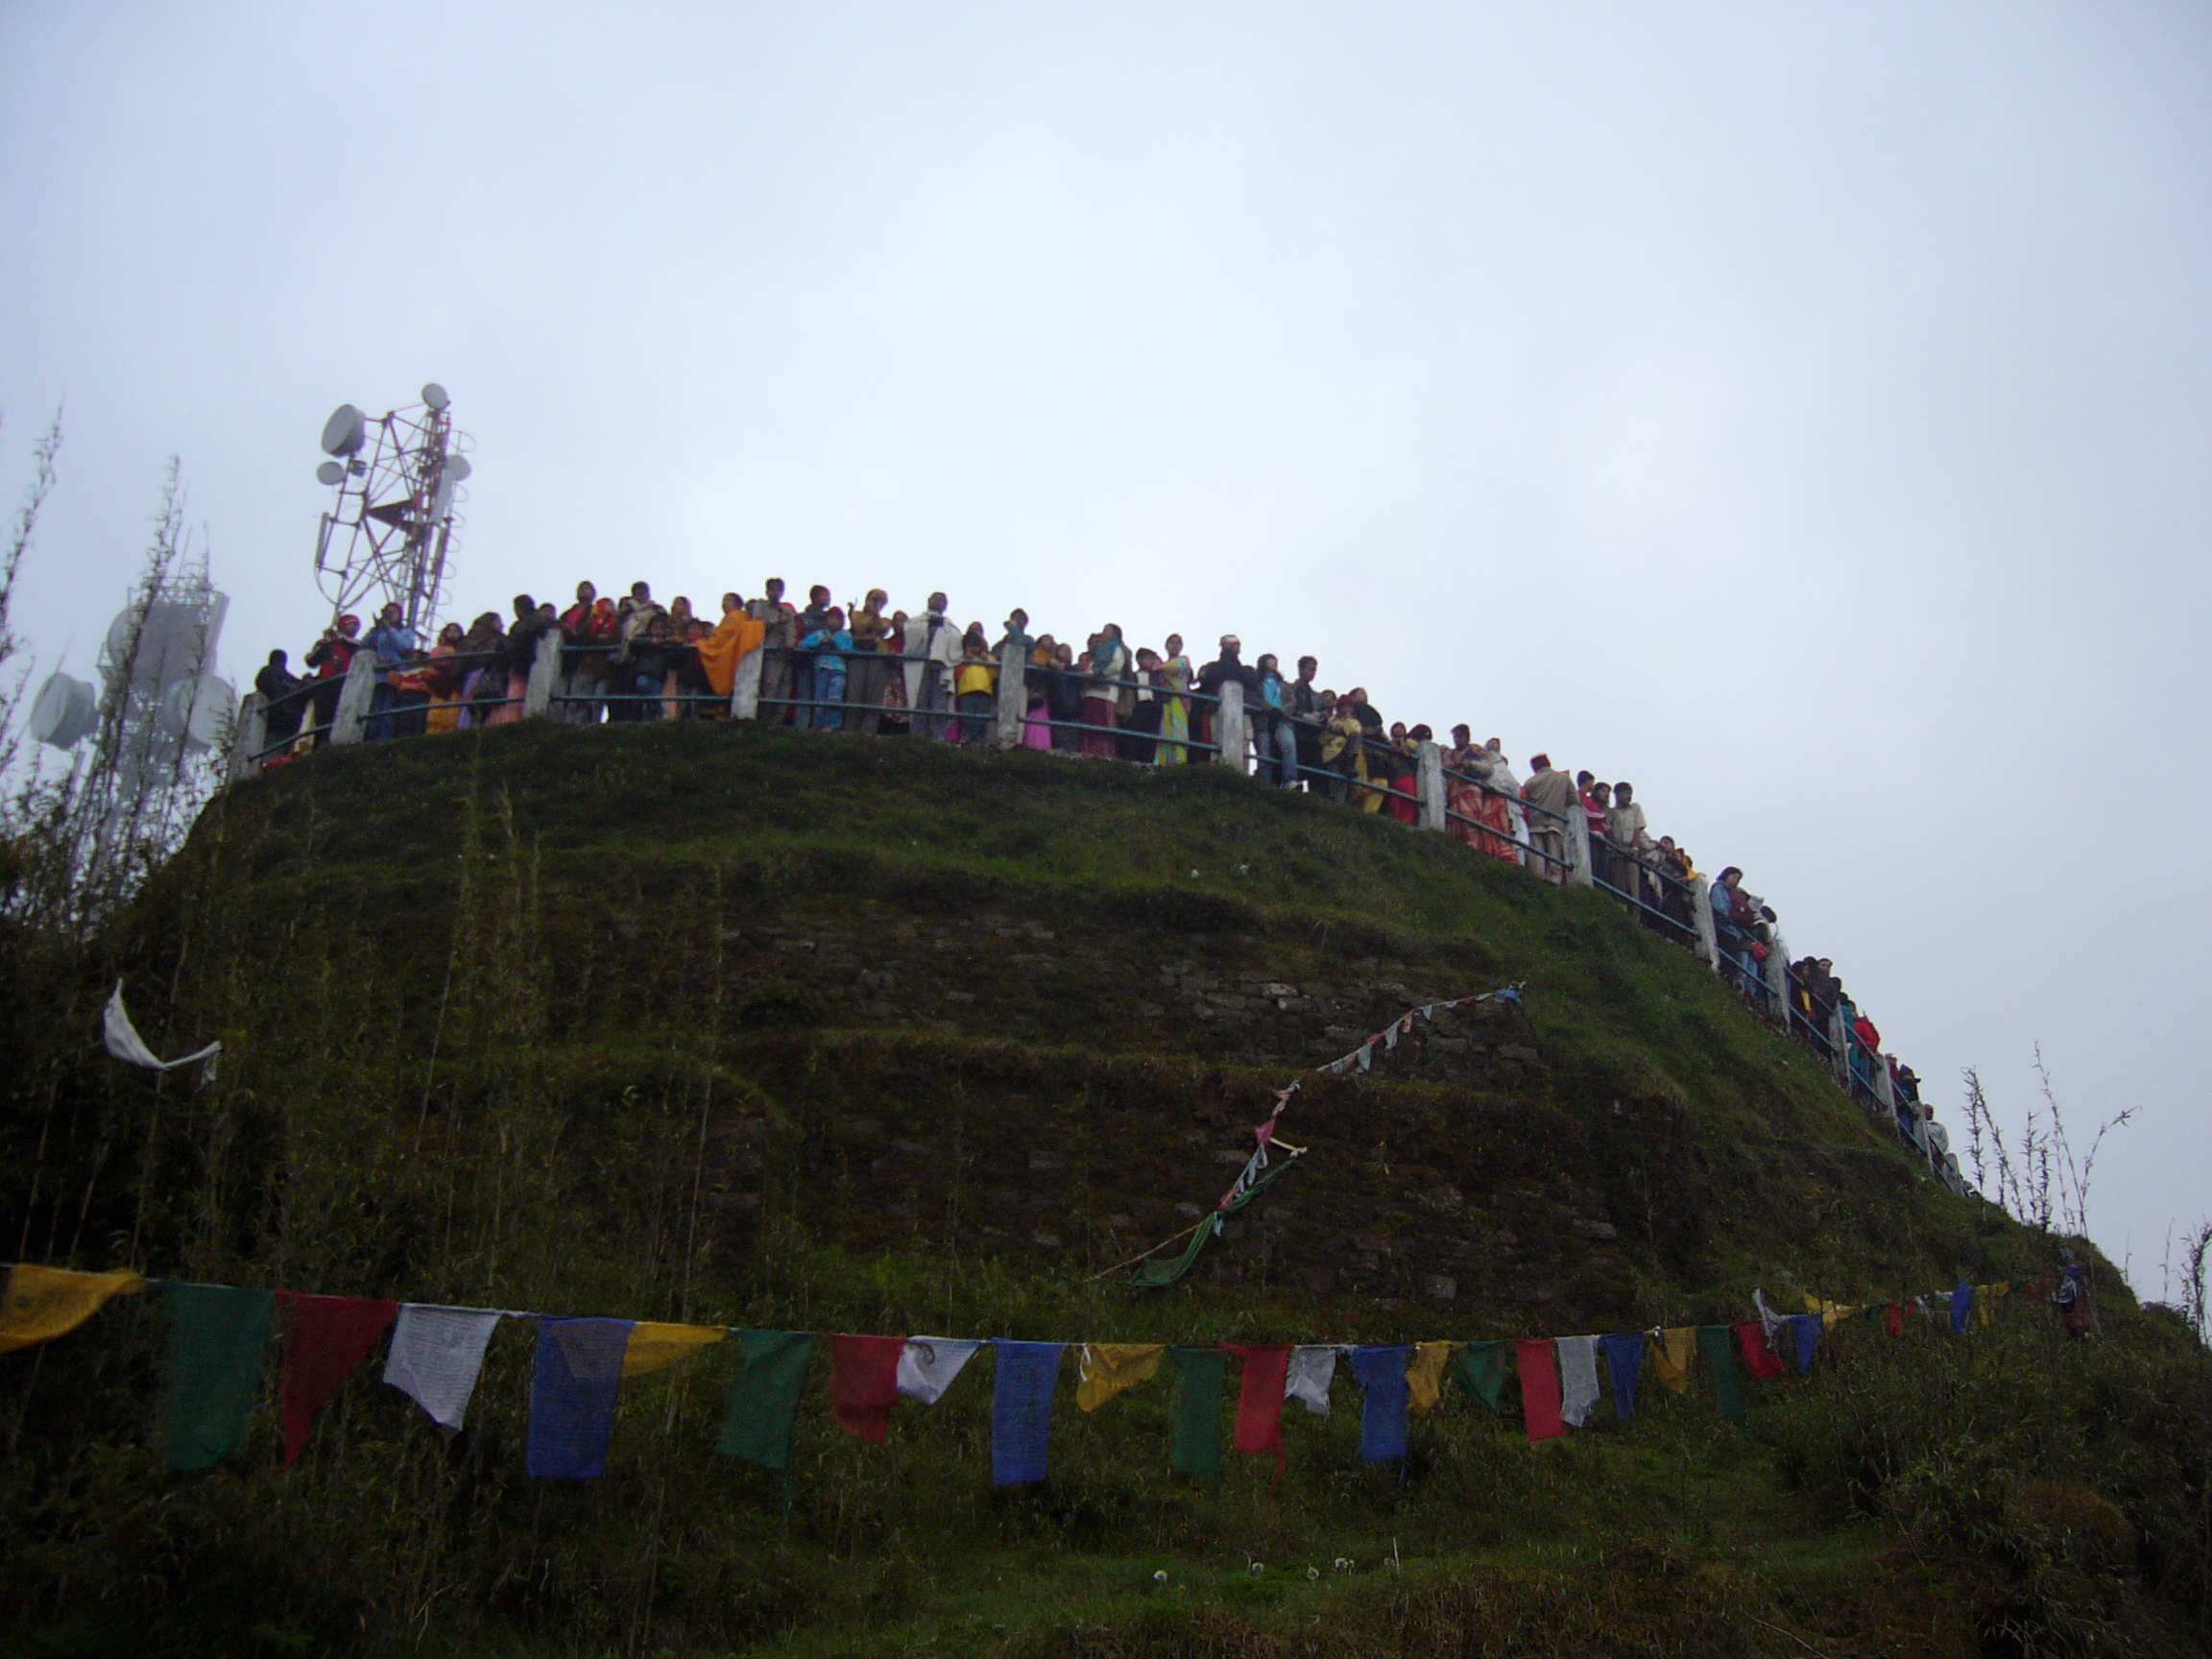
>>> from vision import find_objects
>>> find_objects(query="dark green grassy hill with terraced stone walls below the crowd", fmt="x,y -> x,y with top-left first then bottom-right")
0,726 -> 2212,1654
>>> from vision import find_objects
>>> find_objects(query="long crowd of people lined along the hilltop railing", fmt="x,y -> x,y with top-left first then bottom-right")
254,577 -> 1955,1185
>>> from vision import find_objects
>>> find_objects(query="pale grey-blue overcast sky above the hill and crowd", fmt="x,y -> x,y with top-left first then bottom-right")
0,0 -> 2212,1296
